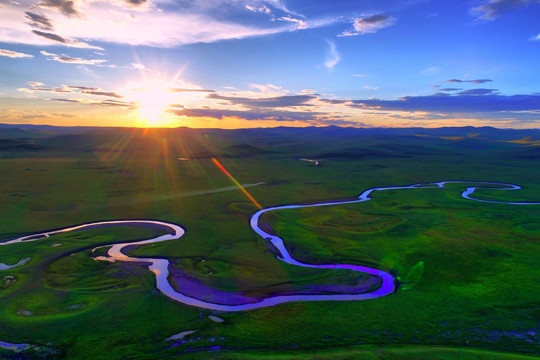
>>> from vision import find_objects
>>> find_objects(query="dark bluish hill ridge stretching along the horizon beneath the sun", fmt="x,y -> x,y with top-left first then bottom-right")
0,124 -> 540,160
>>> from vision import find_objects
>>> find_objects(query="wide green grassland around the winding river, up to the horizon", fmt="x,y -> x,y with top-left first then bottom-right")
0,128 -> 540,360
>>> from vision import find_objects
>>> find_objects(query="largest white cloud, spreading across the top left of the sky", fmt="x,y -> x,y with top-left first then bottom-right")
0,0 -> 322,49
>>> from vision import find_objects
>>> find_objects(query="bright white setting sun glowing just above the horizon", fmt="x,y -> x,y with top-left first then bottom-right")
126,79 -> 177,127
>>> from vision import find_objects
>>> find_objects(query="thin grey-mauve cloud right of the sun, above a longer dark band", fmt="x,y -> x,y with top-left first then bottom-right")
207,94 -> 316,109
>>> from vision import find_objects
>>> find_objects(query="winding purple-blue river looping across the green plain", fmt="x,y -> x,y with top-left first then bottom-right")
0,181 -> 540,311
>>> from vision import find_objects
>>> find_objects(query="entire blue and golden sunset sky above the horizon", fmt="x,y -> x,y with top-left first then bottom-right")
0,0 -> 540,128
